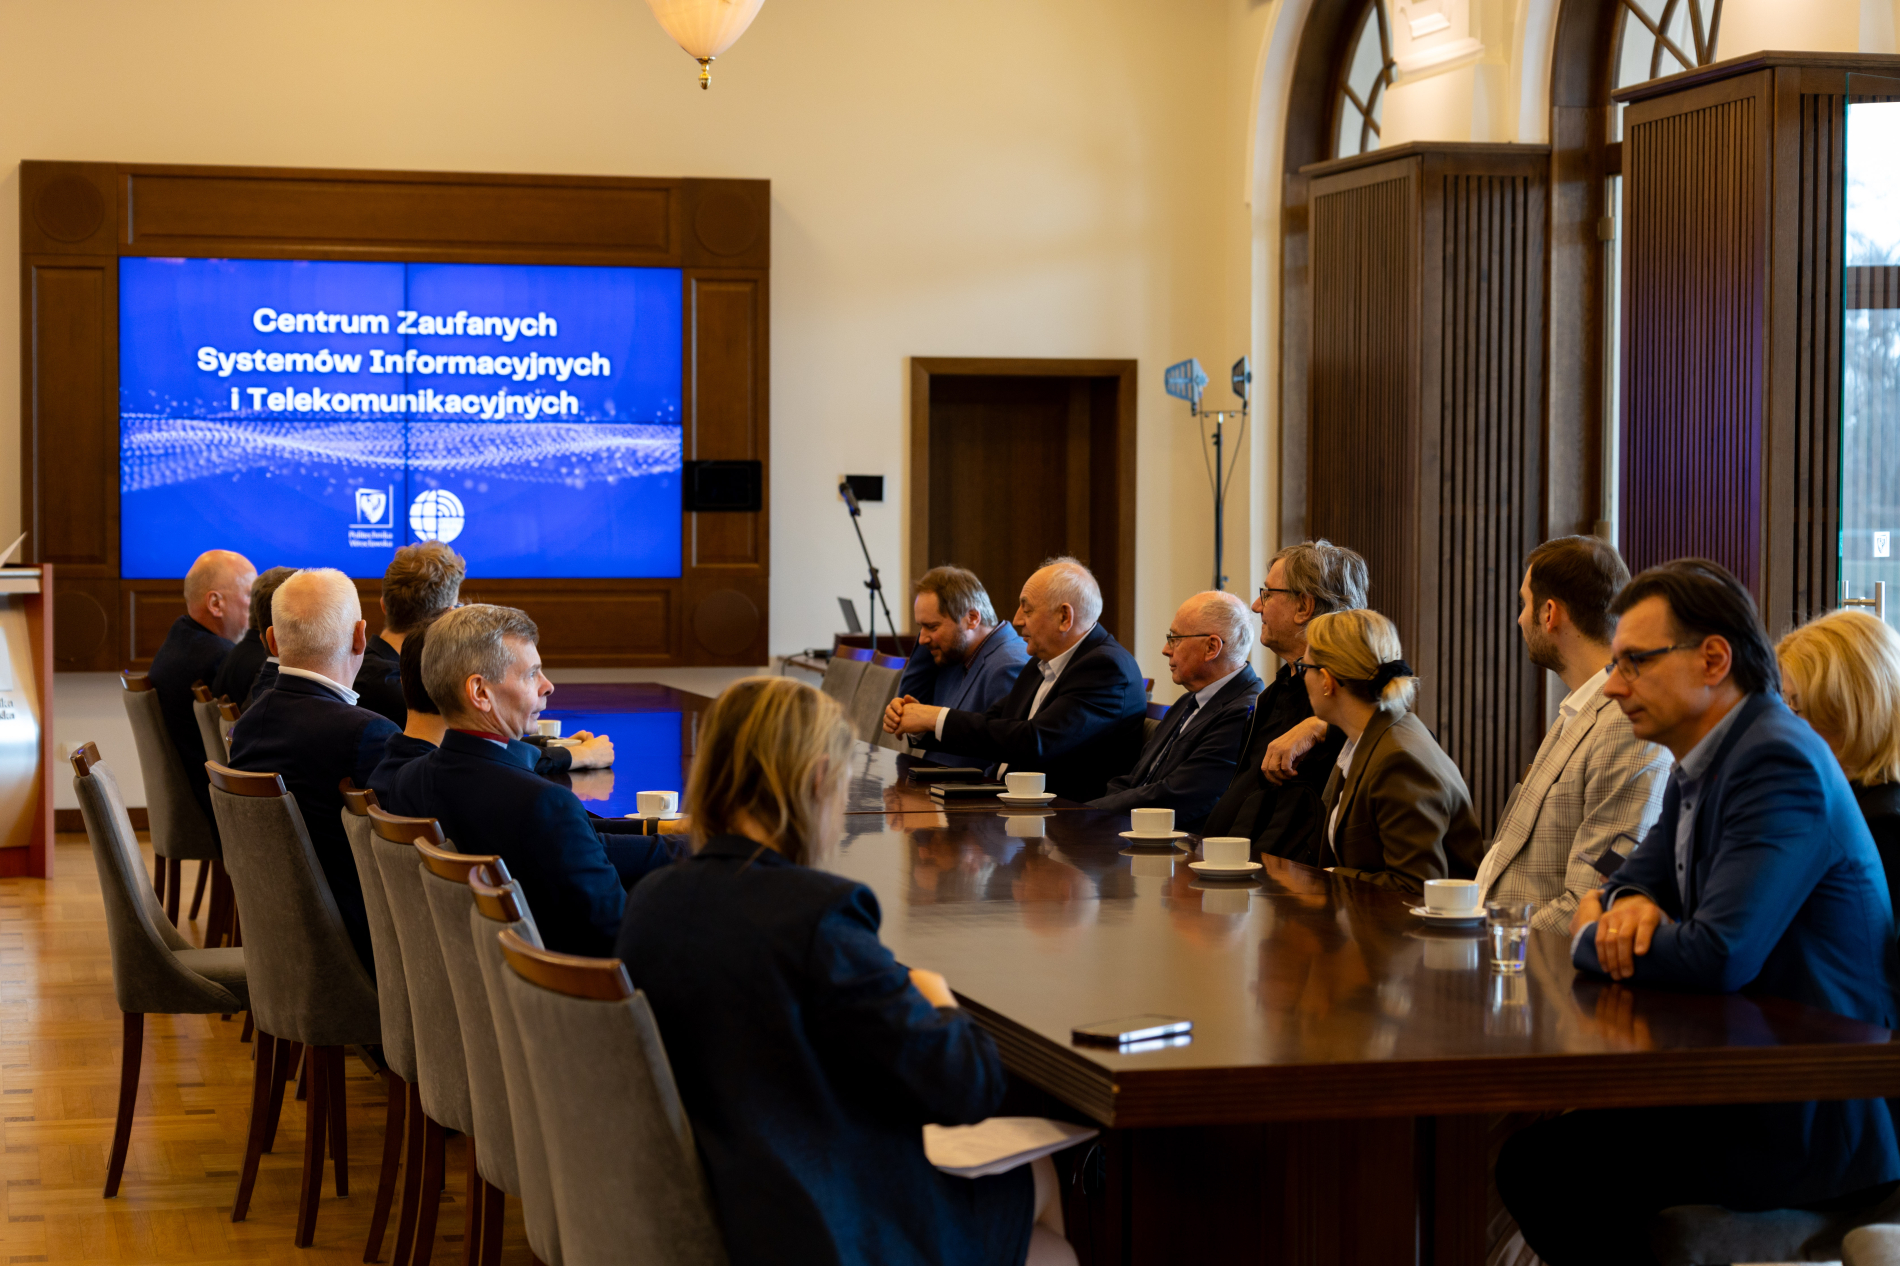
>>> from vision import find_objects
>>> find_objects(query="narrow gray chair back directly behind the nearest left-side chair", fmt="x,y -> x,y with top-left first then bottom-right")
469,869 -> 564,1266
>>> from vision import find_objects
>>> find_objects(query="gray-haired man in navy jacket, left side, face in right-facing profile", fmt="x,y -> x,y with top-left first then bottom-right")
378,603 -> 682,954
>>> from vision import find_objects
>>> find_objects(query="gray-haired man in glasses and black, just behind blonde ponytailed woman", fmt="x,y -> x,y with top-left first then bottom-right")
1201,540 -> 1366,865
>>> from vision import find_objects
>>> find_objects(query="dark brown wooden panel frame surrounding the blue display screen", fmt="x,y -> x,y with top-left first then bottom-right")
19,162 -> 771,671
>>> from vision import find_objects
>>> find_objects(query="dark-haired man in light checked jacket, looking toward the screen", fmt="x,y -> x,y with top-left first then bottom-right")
1478,536 -> 1672,931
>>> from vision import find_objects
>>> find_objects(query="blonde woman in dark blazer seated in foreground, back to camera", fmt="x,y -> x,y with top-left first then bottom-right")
616,677 -> 1075,1266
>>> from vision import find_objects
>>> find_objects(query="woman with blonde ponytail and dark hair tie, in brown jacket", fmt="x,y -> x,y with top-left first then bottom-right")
1292,608 -> 1484,895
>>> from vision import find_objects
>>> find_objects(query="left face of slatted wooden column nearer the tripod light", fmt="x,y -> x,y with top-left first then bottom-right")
1307,163 -> 1419,646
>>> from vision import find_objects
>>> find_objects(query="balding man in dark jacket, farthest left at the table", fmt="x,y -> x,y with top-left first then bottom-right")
150,549 -> 257,823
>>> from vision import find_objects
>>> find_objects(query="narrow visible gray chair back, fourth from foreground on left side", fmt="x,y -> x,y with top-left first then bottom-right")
369,808 -> 481,1132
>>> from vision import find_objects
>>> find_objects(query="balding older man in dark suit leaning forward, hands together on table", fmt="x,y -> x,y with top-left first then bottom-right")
884,559 -> 1148,800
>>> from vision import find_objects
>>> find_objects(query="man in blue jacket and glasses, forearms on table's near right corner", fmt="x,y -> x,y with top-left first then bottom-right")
1497,559 -> 1900,1266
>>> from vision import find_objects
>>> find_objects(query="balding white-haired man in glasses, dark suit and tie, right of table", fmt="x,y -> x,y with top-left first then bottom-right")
1089,589 -> 1260,831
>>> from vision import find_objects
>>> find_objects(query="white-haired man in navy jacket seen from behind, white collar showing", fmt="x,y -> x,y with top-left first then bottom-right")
232,566 -> 395,969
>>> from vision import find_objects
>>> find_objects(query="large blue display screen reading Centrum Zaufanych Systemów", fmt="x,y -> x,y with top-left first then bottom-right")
120,259 -> 682,580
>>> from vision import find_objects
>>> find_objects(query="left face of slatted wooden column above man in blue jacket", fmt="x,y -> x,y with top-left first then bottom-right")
1623,97 -> 1767,593
